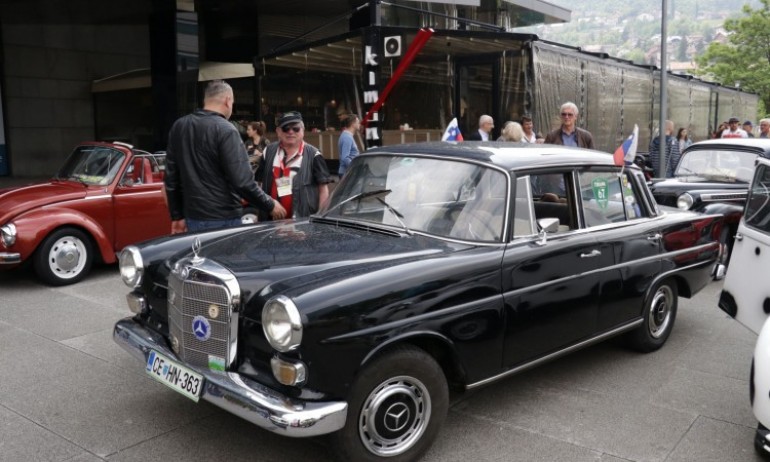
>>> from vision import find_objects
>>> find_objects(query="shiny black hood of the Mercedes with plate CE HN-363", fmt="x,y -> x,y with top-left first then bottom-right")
188,221 -> 477,304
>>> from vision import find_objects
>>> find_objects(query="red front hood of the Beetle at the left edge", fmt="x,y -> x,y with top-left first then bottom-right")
0,180 -> 86,224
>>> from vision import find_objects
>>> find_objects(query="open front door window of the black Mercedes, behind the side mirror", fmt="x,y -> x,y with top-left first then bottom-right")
530,172 -> 578,232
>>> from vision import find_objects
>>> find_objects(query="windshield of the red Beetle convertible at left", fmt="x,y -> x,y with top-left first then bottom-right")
56,146 -> 125,185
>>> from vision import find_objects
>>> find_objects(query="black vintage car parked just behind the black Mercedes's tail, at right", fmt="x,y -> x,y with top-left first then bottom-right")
650,138 -> 770,253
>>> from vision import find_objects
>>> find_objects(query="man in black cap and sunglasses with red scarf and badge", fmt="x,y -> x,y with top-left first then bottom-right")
256,111 -> 331,219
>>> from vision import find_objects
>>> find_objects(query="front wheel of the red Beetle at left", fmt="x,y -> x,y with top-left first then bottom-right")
34,228 -> 93,286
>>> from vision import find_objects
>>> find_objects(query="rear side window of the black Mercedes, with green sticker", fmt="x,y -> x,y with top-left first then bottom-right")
578,171 -> 644,227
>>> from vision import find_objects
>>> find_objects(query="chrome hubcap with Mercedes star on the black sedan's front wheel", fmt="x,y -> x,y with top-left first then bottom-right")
359,376 -> 431,457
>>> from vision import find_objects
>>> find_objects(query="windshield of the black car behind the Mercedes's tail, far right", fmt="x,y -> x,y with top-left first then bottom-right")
674,149 -> 757,183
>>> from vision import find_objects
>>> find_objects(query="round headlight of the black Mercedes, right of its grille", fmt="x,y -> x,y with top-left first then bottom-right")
262,295 -> 302,353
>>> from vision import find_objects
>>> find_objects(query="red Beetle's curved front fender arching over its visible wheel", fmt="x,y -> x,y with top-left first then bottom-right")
13,207 -> 116,263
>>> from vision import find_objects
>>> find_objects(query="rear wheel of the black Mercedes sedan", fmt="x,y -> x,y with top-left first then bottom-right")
628,279 -> 679,353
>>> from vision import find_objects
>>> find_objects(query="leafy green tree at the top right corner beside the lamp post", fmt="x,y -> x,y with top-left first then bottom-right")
698,0 -> 770,112
